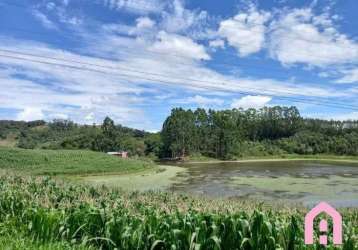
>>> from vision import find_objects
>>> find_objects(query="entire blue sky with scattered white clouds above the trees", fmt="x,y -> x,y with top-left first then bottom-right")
0,0 -> 358,131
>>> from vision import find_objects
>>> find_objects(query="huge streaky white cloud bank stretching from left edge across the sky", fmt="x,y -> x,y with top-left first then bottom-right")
0,7 -> 349,129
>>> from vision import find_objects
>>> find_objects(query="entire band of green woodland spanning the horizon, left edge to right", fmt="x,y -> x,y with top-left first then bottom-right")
0,106 -> 358,159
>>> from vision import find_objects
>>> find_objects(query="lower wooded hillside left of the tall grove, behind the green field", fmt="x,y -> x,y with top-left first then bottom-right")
0,117 -> 160,156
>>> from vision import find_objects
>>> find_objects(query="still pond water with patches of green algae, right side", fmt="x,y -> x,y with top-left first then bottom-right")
171,161 -> 358,207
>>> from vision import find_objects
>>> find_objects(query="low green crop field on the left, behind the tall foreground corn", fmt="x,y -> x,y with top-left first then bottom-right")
0,147 -> 156,175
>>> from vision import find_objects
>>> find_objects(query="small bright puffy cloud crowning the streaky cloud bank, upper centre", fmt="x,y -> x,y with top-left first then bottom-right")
150,31 -> 210,60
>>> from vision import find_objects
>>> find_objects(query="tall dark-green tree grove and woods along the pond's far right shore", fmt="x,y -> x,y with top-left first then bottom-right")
162,106 -> 358,159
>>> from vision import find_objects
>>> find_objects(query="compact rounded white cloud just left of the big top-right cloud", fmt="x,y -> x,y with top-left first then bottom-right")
218,6 -> 270,57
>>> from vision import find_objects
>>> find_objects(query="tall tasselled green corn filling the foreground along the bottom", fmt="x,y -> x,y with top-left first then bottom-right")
0,175 -> 358,250
